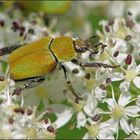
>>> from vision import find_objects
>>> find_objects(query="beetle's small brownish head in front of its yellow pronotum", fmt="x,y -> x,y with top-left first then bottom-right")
73,36 -> 100,54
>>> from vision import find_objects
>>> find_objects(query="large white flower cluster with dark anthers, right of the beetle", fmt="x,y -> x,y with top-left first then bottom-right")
63,12 -> 140,139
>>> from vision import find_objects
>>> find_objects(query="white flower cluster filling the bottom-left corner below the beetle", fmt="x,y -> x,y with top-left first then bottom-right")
0,82 -> 56,139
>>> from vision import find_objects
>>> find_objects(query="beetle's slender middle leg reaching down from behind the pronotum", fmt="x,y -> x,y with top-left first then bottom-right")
60,64 -> 82,100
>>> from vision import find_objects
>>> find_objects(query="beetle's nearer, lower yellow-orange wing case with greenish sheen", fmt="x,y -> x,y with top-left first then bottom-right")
9,50 -> 56,80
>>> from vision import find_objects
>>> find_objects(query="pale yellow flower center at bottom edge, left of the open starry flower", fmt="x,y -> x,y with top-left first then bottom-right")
86,124 -> 100,138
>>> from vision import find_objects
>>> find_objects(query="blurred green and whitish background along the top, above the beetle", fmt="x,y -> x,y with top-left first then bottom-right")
0,0 -> 140,37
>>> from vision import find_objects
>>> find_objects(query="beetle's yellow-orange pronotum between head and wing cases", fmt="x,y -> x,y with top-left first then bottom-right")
51,36 -> 77,62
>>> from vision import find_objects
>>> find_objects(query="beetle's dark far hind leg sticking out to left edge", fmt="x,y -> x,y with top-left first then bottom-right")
0,43 -> 27,56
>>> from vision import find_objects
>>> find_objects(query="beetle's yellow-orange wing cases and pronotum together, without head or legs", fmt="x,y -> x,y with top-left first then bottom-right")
9,37 -> 76,80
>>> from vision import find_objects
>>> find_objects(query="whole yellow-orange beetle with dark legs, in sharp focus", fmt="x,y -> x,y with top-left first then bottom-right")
0,36 -> 117,99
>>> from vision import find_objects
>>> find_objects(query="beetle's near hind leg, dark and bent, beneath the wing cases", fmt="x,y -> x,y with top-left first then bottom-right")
13,77 -> 45,95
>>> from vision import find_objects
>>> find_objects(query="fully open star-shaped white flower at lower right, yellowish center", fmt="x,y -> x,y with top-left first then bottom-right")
105,89 -> 140,134
